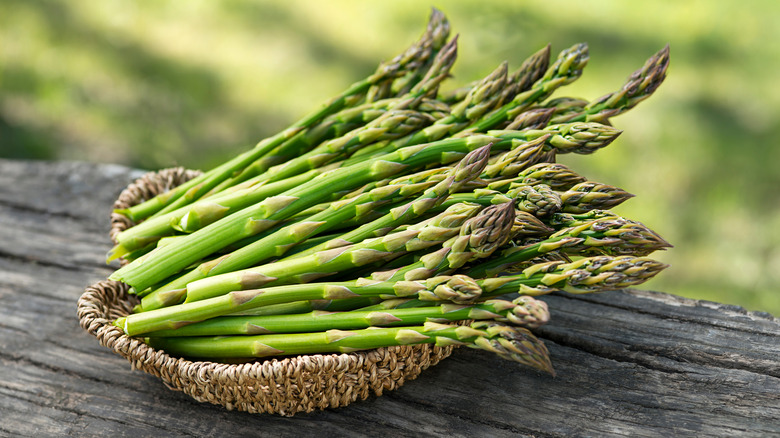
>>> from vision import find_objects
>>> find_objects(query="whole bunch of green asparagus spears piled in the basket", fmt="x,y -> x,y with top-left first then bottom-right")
108,10 -> 670,373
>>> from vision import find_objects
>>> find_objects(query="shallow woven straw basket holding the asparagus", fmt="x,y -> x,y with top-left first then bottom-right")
78,168 -> 453,416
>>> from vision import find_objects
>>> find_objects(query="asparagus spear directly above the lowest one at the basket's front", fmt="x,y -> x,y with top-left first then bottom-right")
146,296 -> 549,337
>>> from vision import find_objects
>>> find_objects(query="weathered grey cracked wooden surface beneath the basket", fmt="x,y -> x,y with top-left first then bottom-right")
0,160 -> 780,437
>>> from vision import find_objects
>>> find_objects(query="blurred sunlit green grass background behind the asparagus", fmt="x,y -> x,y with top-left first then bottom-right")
0,0 -> 780,315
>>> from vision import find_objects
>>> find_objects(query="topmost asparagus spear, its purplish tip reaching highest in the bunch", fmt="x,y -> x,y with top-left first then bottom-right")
112,10 -> 449,222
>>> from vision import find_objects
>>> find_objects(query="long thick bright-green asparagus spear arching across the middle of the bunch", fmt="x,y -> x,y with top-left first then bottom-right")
110,123 -> 620,290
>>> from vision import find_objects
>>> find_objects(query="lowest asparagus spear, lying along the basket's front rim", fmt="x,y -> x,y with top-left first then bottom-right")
148,322 -> 554,374
